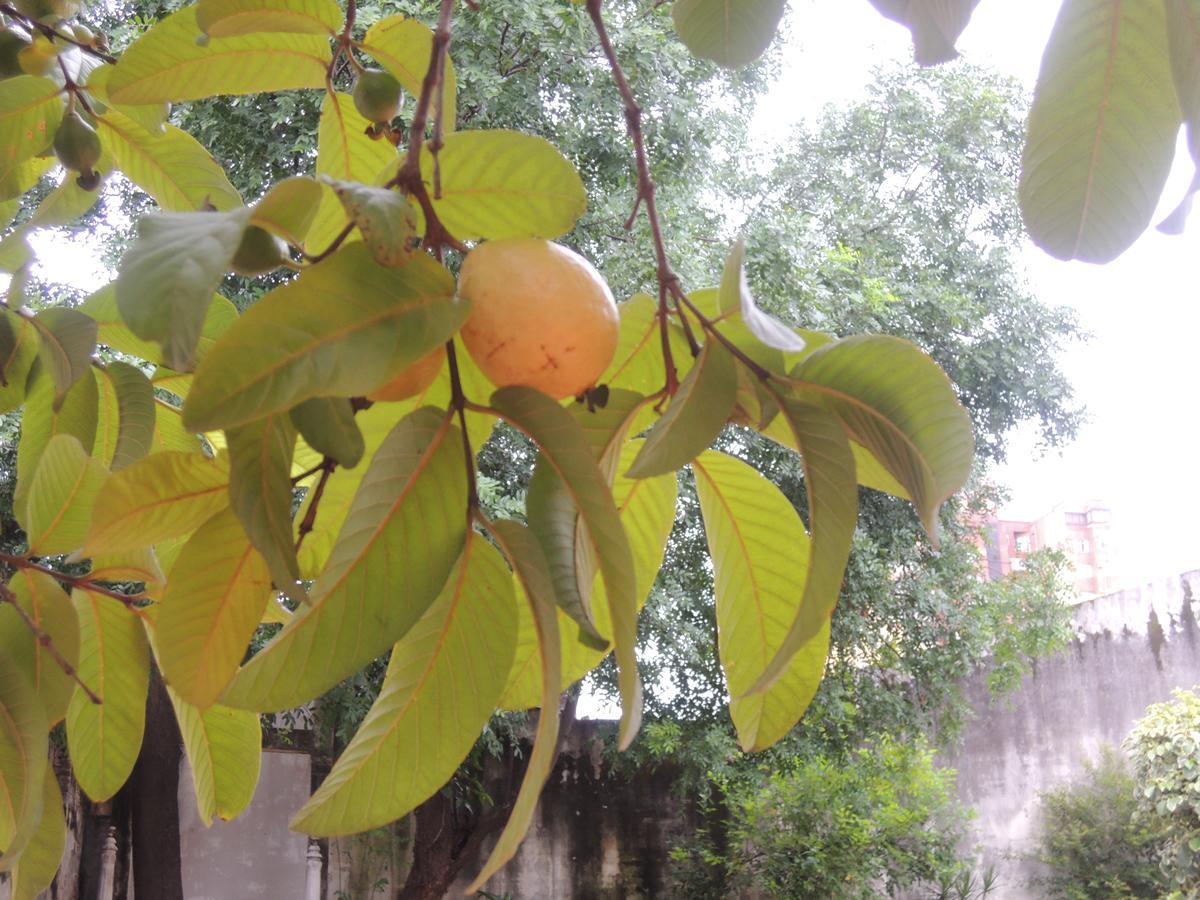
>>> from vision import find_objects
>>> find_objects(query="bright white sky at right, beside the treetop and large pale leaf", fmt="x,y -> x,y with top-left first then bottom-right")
756,0 -> 1200,581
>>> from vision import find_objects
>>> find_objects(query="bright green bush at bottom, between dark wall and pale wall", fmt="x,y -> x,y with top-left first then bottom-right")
673,739 -> 980,900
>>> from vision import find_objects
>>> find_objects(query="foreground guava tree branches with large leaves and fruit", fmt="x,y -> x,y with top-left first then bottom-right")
0,0 -> 1198,896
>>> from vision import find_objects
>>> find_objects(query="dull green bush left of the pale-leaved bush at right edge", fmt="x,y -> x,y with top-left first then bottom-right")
1038,748 -> 1166,900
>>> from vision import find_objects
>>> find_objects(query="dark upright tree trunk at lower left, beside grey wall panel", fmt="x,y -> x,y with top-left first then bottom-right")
126,670 -> 184,900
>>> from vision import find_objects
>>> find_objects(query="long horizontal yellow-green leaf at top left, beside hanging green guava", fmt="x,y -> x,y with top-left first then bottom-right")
108,6 -> 331,104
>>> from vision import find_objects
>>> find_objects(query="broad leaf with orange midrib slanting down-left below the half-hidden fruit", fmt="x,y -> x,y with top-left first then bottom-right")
221,408 -> 467,712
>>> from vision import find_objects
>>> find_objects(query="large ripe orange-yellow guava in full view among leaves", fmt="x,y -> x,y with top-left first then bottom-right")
458,238 -> 620,400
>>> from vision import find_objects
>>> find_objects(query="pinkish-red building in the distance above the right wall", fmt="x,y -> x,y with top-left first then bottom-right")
983,500 -> 1120,599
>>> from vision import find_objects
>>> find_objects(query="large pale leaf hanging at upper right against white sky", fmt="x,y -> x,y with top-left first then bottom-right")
1020,0 -> 1180,263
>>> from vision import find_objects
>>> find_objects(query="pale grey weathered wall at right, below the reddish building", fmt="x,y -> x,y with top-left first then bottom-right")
944,571 -> 1200,898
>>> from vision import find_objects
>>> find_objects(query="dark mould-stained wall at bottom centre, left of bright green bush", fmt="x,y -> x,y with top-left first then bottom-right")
446,721 -> 690,900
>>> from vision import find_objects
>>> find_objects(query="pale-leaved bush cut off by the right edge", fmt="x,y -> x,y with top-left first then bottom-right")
1126,690 -> 1200,898
